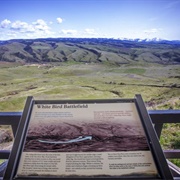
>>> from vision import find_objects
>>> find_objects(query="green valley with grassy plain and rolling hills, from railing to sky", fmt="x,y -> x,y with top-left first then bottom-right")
0,38 -> 180,111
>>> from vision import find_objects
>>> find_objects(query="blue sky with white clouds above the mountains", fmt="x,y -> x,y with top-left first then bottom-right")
0,0 -> 180,40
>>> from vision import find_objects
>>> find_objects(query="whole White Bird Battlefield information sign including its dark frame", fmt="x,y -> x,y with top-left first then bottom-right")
4,95 -> 172,179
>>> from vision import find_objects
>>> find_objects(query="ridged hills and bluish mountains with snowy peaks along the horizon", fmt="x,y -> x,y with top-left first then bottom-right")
0,38 -> 180,65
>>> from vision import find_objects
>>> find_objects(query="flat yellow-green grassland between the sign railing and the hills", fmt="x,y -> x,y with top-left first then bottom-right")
0,63 -> 180,111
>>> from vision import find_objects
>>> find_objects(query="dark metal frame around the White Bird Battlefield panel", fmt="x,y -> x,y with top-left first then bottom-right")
4,94 -> 173,180
